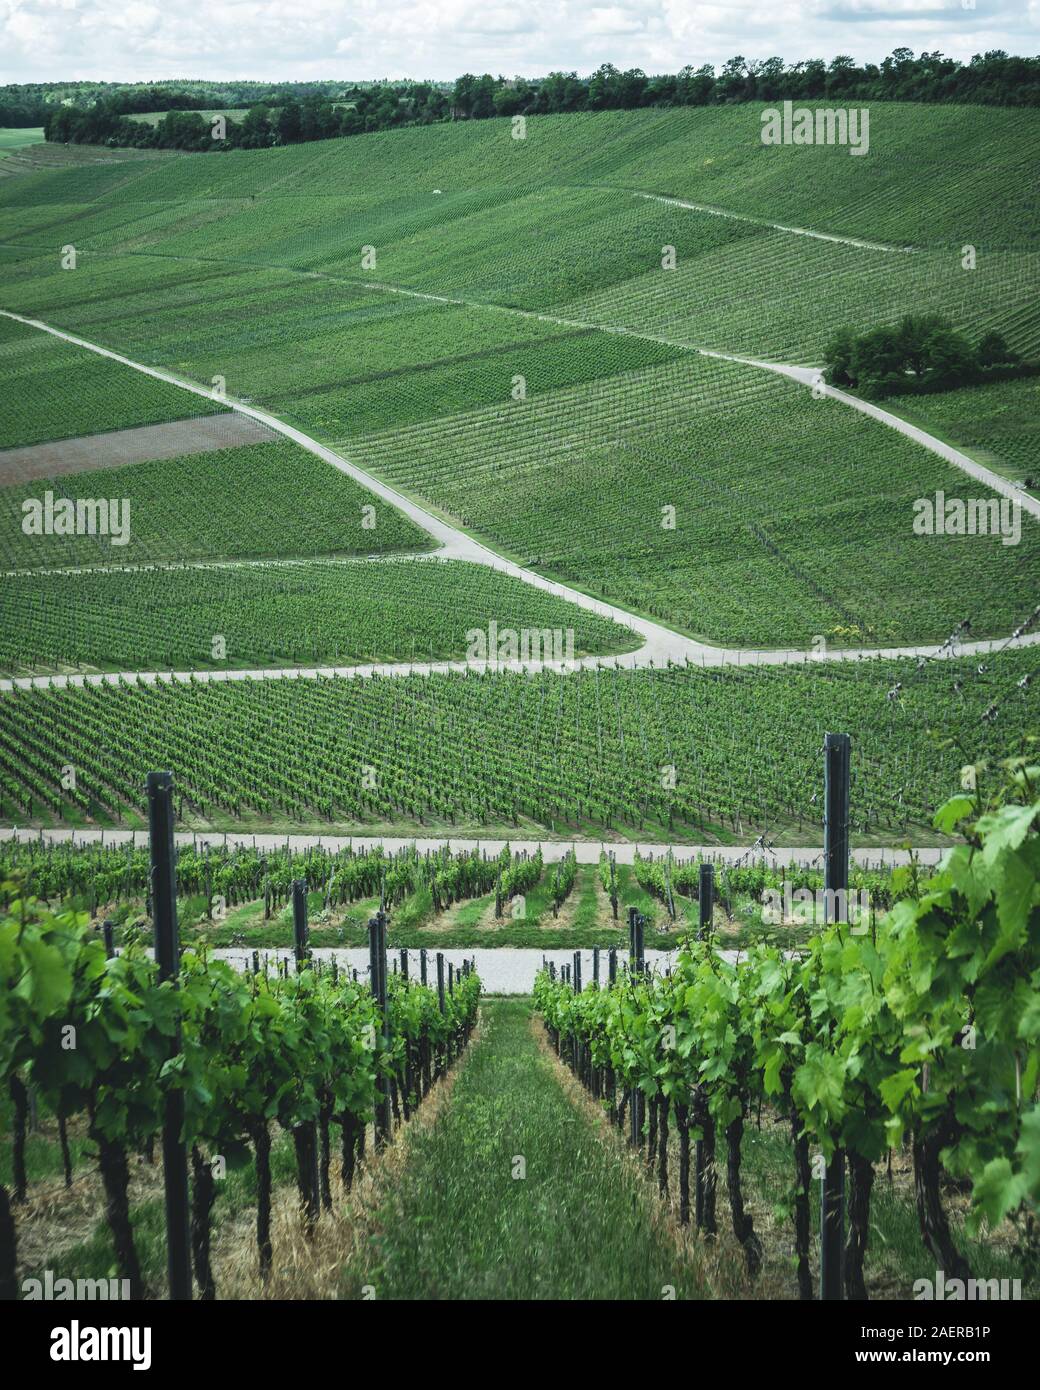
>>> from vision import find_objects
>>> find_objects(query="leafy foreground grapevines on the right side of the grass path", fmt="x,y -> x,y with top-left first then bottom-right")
535,766 -> 1040,1300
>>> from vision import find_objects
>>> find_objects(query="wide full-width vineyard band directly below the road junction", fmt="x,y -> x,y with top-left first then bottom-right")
0,651 -> 1034,844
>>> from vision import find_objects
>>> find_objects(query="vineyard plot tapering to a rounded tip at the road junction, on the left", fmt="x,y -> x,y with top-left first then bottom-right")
0,558 -> 640,674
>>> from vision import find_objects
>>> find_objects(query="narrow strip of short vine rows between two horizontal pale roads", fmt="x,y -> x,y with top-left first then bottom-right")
0,837 -> 894,949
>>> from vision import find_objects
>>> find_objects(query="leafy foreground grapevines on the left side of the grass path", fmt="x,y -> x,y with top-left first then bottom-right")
0,834 -> 480,1300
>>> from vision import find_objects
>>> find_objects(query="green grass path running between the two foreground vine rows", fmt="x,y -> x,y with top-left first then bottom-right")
341,999 -> 704,1300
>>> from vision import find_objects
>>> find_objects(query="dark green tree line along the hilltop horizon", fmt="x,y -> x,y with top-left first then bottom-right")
36,49 -> 1040,150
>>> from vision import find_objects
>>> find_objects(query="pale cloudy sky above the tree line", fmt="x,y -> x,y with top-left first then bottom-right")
0,0 -> 1040,82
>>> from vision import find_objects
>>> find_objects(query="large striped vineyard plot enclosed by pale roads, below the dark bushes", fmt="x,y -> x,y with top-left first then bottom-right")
351,357 -> 1040,648
